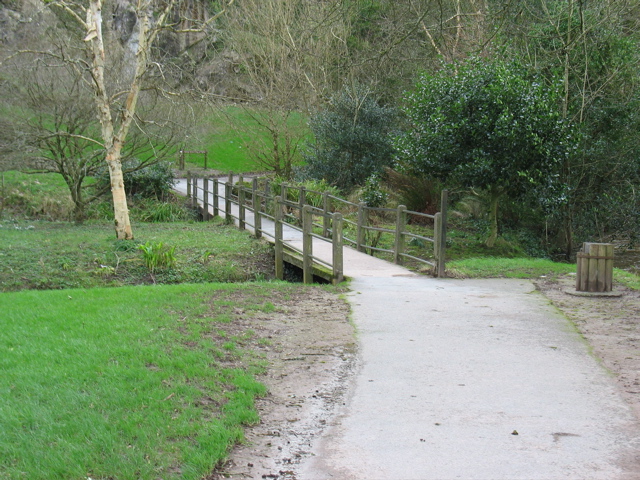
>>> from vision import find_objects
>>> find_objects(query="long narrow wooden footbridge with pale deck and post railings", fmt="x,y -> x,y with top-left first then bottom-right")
176,174 -> 447,283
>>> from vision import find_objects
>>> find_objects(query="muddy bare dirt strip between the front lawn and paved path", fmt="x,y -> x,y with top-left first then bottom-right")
209,288 -> 356,480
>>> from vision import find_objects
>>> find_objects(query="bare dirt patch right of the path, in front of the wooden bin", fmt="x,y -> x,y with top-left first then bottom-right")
535,275 -> 640,419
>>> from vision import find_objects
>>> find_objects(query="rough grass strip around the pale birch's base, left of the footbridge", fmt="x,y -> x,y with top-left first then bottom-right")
0,220 -> 273,292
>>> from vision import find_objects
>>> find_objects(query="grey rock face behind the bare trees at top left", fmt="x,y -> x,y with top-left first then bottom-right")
0,0 -> 252,101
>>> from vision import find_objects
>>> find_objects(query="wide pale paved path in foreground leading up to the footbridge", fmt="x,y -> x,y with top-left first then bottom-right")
175,178 -> 640,480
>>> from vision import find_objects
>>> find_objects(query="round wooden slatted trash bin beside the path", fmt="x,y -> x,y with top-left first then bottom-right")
576,243 -> 613,292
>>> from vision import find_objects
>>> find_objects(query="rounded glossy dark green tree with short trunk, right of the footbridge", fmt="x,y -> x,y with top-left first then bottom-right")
397,59 -> 575,246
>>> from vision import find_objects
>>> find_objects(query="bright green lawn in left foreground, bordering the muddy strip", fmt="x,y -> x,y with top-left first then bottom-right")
0,283 -> 299,480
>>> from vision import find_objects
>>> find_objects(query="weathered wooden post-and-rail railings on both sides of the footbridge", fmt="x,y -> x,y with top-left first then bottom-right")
187,174 -> 447,283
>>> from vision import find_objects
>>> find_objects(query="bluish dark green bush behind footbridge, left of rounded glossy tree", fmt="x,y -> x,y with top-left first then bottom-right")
302,86 -> 397,191
